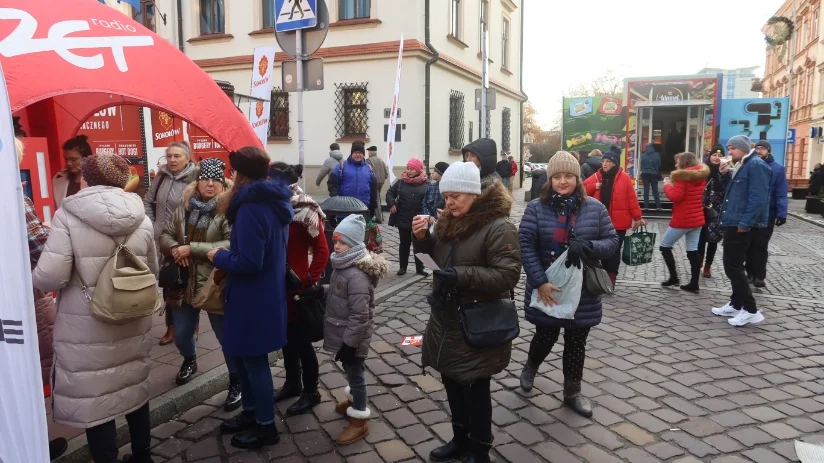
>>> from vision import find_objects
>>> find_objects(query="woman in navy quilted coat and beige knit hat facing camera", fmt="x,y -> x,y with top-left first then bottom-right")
520,151 -> 619,418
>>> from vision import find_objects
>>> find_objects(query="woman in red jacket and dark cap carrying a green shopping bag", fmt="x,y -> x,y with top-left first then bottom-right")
584,151 -> 647,284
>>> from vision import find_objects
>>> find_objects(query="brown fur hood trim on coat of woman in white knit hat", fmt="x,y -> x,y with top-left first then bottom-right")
435,182 -> 512,241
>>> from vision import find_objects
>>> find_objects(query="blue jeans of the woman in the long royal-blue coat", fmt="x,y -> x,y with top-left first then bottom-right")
236,354 -> 275,424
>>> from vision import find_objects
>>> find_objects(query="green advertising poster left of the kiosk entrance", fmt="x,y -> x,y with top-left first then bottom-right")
562,95 -> 624,152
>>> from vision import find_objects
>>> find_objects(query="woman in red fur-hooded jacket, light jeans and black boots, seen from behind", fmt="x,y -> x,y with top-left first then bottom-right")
661,153 -> 710,294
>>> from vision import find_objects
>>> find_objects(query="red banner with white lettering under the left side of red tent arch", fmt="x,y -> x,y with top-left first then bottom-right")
77,105 -> 143,159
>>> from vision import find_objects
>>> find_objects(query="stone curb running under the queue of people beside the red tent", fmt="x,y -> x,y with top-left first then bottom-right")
54,351 -> 281,463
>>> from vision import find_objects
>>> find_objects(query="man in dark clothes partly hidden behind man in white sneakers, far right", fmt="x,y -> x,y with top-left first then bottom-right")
747,140 -> 790,288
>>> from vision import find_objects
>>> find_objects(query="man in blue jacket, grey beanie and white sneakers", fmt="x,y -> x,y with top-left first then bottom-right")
712,135 -> 772,326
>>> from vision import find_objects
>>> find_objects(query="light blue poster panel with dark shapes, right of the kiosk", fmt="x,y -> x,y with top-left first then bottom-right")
718,98 -> 790,166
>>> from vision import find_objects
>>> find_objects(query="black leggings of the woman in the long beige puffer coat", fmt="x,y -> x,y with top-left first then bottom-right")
86,402 -> 152,463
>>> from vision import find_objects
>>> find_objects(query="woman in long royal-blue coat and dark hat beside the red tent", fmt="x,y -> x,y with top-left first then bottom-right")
208,146 -> 293,449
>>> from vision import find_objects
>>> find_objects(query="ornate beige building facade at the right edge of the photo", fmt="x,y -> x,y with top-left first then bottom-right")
762,0 -> 824,187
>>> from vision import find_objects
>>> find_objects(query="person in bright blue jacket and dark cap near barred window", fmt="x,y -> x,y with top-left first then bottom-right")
327,141 -> 378,216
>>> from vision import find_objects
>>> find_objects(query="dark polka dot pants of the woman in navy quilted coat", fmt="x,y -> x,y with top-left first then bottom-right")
529,327 -> 589,381
